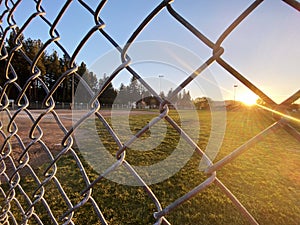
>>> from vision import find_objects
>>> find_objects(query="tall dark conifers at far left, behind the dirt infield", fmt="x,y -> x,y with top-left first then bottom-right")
0,33 -> 116,106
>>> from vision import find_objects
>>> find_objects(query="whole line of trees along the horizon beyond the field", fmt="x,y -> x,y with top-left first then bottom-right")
0,34 -> 208,108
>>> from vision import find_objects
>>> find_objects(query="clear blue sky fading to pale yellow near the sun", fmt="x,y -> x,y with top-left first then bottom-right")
2,0 -> 300,102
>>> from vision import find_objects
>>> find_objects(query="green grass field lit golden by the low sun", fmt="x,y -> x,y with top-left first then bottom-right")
7,109 -> 300,225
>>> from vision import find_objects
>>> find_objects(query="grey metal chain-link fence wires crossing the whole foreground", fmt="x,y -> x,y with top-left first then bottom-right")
0,0 -> 300,224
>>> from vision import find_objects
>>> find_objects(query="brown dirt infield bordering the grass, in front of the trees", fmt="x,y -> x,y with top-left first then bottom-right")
0,110 -> 157,181
